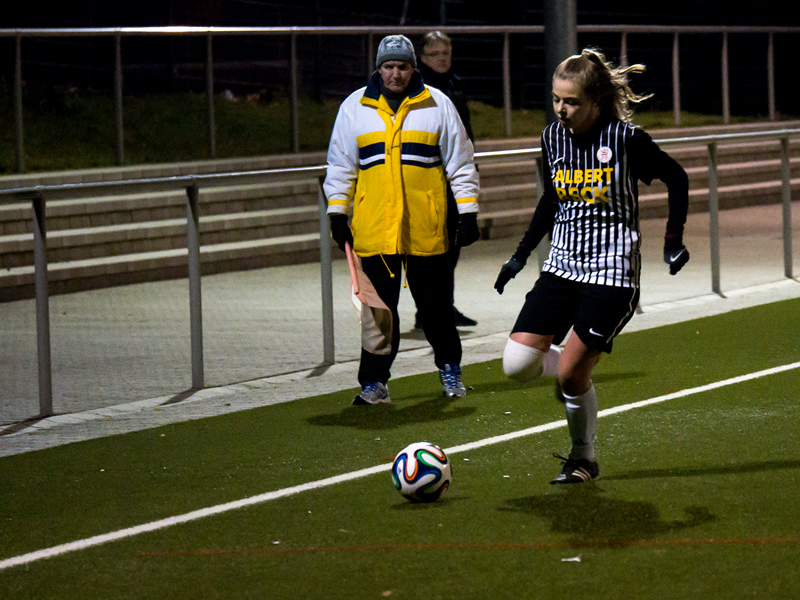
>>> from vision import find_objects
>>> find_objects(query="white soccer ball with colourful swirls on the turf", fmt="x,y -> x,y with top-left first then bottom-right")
392,442 -> 451,502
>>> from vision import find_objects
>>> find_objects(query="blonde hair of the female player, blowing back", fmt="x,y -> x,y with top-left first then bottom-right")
553,48 -> 652,123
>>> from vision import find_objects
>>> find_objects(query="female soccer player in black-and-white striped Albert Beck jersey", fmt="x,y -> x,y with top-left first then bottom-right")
494,49 -> 689,484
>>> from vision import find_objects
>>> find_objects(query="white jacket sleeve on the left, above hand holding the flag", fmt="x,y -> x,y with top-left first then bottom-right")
323,96 -> 358,215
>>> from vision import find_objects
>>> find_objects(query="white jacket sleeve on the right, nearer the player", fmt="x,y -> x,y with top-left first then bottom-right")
429,88 -> 480,214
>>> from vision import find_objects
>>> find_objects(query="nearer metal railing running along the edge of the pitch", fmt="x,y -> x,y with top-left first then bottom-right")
0,129 -> 800,417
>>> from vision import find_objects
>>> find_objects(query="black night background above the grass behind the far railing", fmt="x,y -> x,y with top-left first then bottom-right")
0,0 -> 800,115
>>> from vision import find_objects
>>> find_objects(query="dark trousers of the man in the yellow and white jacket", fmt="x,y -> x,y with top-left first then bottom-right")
358,254 -> 461,383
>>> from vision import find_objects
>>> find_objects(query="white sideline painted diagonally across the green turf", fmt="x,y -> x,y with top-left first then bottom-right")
0,362 -> 800,571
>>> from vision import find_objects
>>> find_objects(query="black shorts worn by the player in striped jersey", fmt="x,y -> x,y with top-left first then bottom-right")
511,273 -> 639,352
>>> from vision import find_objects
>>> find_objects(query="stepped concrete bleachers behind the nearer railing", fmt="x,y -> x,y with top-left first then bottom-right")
0,122 -> 800,301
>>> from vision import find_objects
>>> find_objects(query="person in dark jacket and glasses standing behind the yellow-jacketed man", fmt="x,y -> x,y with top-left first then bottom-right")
414,31 -> 478,328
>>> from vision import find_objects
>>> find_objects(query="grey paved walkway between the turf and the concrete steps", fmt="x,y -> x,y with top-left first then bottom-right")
0,202 -> 800,456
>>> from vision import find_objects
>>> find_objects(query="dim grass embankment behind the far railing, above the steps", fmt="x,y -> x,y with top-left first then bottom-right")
0,88 -> 788,174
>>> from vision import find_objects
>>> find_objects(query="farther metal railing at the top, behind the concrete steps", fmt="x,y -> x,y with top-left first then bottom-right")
0,25 -> 800,173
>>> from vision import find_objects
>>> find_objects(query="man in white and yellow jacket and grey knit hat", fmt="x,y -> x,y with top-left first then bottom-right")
324,35 -> 480,404
